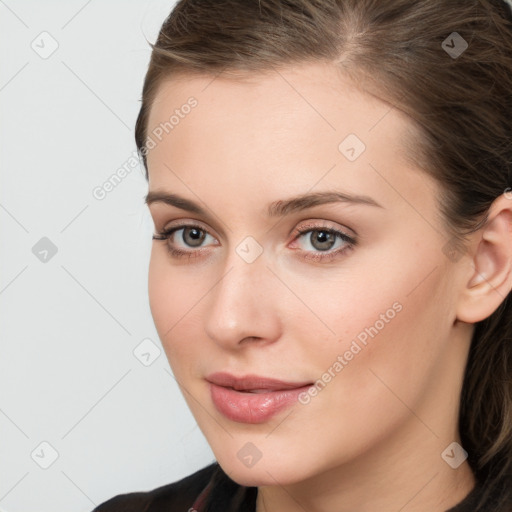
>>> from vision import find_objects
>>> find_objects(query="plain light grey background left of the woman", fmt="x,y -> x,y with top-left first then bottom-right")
0,0 -> 214,512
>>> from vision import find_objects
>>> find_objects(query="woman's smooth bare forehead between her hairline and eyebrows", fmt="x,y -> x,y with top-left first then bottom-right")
143,63 -> 432,218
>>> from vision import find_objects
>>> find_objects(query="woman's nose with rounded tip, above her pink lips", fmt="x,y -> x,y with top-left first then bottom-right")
203,246 -> 284,350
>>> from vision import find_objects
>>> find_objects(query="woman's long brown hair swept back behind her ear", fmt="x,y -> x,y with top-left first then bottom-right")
135,0 -> 512,512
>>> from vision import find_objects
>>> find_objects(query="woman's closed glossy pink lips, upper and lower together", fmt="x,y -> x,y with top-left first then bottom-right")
206,372 -> 313,423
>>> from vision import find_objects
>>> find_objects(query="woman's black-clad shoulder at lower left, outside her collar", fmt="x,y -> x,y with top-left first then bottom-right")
92,462 -> 218,512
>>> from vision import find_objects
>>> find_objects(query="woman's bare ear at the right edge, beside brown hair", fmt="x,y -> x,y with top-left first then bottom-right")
457,192 -> 512,323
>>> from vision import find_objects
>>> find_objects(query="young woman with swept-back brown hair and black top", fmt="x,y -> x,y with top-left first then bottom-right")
95,0 -> 512,512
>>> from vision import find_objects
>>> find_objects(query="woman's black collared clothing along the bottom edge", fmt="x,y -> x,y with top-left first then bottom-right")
92,462 -> 494,512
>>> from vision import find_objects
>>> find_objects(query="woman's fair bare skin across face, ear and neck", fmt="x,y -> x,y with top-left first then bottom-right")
143,63 -> 512,512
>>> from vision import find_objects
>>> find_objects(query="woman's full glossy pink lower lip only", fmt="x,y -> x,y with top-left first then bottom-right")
210,383 -> 311,423
